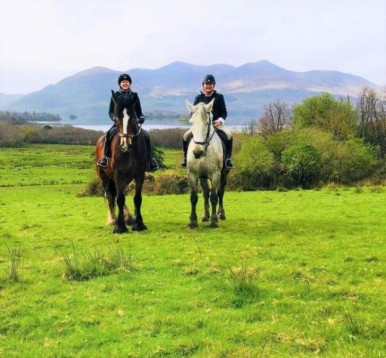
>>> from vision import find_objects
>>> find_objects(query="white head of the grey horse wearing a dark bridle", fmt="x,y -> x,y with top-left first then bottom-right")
186,99 -> 214,158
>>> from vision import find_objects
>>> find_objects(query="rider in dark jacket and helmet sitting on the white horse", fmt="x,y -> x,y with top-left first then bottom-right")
181,74 -> 233,169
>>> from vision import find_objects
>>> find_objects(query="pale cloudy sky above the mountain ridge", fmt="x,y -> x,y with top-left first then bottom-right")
0,0 -> 386,94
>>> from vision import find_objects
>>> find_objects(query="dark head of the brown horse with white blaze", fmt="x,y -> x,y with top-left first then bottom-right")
111,91 -> 141,152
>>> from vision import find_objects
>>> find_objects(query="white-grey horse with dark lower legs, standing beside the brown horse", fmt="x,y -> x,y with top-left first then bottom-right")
186,99 -> 229,228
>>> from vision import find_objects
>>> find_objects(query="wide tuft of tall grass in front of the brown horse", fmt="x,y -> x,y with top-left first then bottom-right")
63,245 -> 132,281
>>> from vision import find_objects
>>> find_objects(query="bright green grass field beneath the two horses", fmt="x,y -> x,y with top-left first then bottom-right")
0,146 -> 386,357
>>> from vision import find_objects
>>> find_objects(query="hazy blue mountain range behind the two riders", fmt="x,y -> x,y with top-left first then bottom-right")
0,60 -> 377,125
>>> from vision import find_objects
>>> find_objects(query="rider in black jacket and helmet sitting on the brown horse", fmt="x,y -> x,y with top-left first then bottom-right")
97,73 -> 159,171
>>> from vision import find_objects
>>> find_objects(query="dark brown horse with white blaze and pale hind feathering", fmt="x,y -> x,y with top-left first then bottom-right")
95,91 -> 147,234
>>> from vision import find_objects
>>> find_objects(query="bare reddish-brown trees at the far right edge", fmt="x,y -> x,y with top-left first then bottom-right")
357,87 -> 386,158
